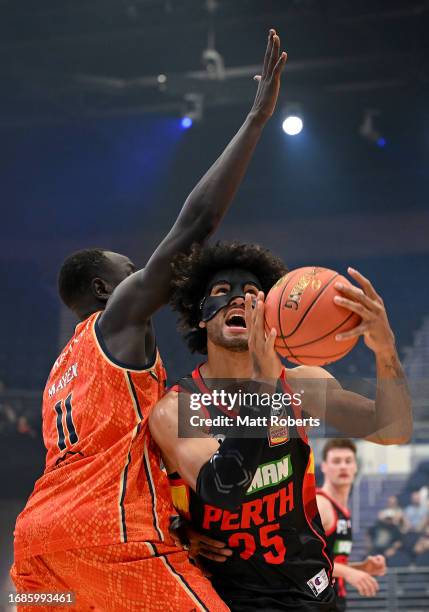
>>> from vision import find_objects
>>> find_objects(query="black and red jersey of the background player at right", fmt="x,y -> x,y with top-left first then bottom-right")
317,489 -> 352,604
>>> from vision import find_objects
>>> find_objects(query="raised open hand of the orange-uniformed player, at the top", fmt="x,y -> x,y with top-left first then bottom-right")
252,29 -> 287,121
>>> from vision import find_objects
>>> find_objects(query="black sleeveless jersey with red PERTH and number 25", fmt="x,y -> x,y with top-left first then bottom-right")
170,368 -> 333,603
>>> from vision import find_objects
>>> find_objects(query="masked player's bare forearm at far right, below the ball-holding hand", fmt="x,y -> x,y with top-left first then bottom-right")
374,347 -> 413,444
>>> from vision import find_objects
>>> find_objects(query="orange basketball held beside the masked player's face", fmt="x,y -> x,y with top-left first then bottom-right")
265,266 -> 361,366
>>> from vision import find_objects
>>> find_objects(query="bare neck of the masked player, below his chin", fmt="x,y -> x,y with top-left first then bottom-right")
201,345 -> 252,378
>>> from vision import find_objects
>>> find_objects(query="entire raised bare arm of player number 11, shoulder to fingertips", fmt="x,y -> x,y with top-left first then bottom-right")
99,30 -> 287,367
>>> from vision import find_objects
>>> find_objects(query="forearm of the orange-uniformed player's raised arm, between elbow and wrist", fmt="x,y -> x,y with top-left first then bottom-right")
178,111 -> 266,243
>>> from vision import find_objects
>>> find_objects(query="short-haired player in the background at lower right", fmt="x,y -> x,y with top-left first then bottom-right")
316,438 -> 386,612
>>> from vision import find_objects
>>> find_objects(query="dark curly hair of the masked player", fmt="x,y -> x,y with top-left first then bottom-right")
170,242 -> 287,354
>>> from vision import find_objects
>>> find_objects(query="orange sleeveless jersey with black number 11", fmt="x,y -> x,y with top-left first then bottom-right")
15,313 -> 172,559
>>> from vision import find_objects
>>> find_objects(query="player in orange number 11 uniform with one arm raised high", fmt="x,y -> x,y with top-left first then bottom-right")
11,30 -> 286,612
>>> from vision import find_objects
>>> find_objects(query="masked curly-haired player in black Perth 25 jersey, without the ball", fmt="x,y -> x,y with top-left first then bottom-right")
150,243 -> 411,612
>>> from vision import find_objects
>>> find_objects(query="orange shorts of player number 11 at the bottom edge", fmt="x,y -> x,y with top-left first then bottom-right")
11,542 -> 229,612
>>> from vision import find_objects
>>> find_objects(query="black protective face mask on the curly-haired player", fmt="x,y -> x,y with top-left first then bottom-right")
200,268 -> 262,322
